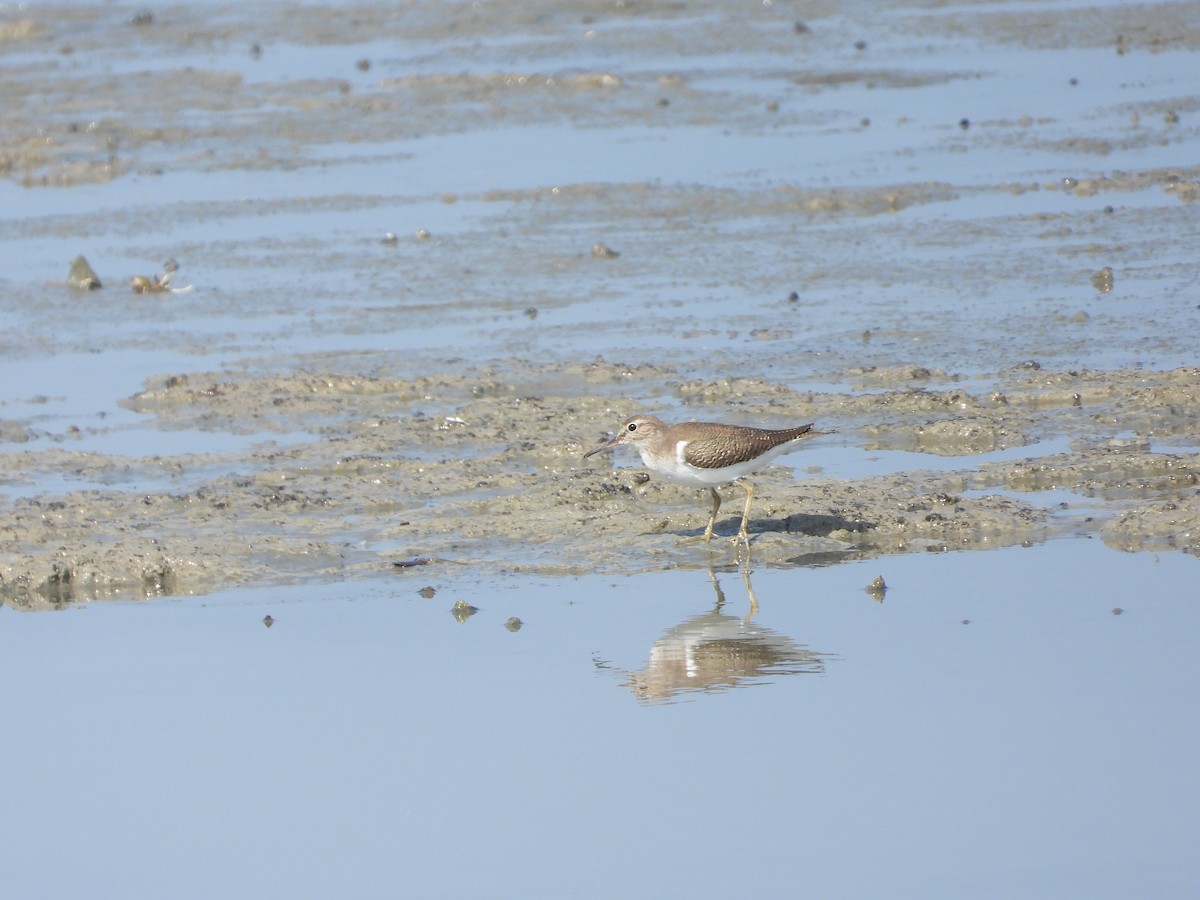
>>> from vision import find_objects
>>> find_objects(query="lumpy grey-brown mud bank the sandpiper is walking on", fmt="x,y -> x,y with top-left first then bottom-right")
0,361 -> 1200,607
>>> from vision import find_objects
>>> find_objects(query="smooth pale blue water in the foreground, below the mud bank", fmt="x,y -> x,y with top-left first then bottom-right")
0,540 -> 1200,898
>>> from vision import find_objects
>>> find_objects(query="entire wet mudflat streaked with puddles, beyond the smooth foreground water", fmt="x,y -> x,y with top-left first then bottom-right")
0,1 -> 1200,607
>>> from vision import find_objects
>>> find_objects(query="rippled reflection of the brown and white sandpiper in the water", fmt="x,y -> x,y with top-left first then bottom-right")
596,566 -> 830,703
